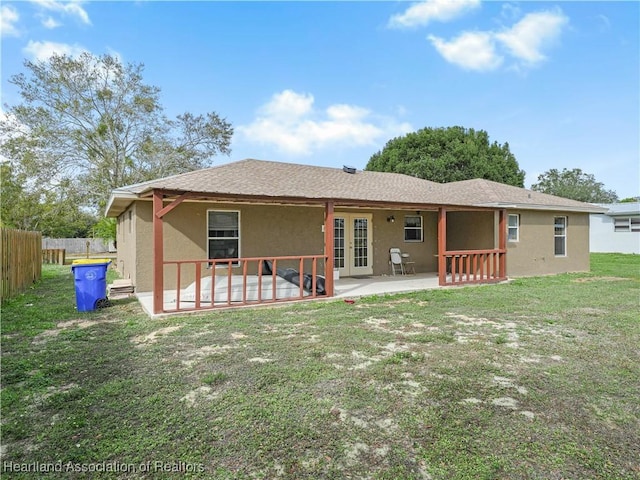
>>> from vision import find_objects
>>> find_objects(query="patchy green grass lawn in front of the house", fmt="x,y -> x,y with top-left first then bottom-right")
1,254 -> 640,480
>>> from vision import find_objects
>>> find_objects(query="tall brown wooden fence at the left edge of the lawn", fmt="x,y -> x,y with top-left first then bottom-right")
0,228 -> 42,302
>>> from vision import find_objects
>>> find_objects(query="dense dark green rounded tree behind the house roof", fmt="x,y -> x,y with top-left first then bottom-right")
366,127 -> 524,187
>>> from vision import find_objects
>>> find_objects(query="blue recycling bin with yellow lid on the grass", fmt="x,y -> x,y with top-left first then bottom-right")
71,260 -> 111,312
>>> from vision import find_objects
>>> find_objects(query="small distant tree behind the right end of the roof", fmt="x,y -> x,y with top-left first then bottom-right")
531,168 -> 618,203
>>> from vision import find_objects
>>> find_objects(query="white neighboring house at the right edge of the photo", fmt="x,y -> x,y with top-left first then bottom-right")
589,202 -> 640,254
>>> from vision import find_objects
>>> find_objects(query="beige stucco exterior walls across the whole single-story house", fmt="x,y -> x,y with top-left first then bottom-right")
117,201 -> 589,292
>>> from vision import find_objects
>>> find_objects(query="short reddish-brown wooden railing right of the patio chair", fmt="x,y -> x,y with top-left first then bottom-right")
441,249 -> 507,285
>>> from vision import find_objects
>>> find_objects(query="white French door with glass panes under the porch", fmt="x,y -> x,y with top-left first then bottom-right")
333,213 -> 373,277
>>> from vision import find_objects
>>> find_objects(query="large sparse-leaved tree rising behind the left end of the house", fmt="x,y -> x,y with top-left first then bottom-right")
0,53 -> 233,212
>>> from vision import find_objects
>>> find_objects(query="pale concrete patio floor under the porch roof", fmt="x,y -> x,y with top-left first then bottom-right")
136,272 -> 440,317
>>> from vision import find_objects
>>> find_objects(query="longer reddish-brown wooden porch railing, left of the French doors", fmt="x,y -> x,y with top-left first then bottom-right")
162,255 -> 326,313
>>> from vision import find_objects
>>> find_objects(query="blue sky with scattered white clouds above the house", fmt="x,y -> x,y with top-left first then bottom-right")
0,0 -> 640,198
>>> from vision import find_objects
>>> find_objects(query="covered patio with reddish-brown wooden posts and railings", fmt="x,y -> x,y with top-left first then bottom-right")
142,189 -> 506,315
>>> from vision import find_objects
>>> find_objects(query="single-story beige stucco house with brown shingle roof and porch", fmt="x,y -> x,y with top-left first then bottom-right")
106,159 -> 604,313
